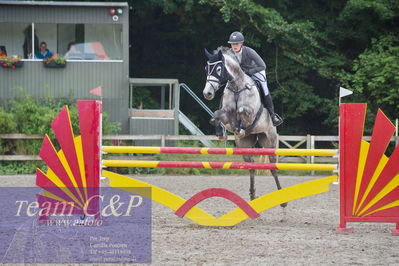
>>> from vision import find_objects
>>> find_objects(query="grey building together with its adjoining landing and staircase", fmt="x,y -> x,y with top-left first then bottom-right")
0,0 -> 216,146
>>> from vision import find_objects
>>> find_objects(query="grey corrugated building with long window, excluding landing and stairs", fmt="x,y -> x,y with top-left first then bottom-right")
0,1 -> 129,133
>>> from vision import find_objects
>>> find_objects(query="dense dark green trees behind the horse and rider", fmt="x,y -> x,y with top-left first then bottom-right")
130,0 -> 399,134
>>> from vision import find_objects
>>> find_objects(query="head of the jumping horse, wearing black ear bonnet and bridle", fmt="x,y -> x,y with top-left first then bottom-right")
202,49 -> 231,100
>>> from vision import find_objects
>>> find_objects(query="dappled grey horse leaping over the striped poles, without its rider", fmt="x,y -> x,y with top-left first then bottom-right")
203,47 -> 287,207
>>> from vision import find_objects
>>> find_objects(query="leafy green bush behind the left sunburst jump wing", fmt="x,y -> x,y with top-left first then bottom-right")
0,93 -> 120,174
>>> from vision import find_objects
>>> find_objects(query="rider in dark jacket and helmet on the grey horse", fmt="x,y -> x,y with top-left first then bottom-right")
228,31 -> 283,126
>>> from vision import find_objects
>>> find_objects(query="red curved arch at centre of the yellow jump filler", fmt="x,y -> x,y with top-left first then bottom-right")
175,188 -> 259,219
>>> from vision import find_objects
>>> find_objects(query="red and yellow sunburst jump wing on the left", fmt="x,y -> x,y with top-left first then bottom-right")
36,101 -> 101,221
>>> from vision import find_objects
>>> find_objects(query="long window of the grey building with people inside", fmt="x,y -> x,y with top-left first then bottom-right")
0,23 -> 122,61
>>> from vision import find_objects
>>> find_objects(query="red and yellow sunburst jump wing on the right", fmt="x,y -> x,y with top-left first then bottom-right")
337,103 -> 399,235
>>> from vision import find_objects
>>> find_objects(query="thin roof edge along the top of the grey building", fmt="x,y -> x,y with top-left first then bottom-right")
0,1 -> 128,7
